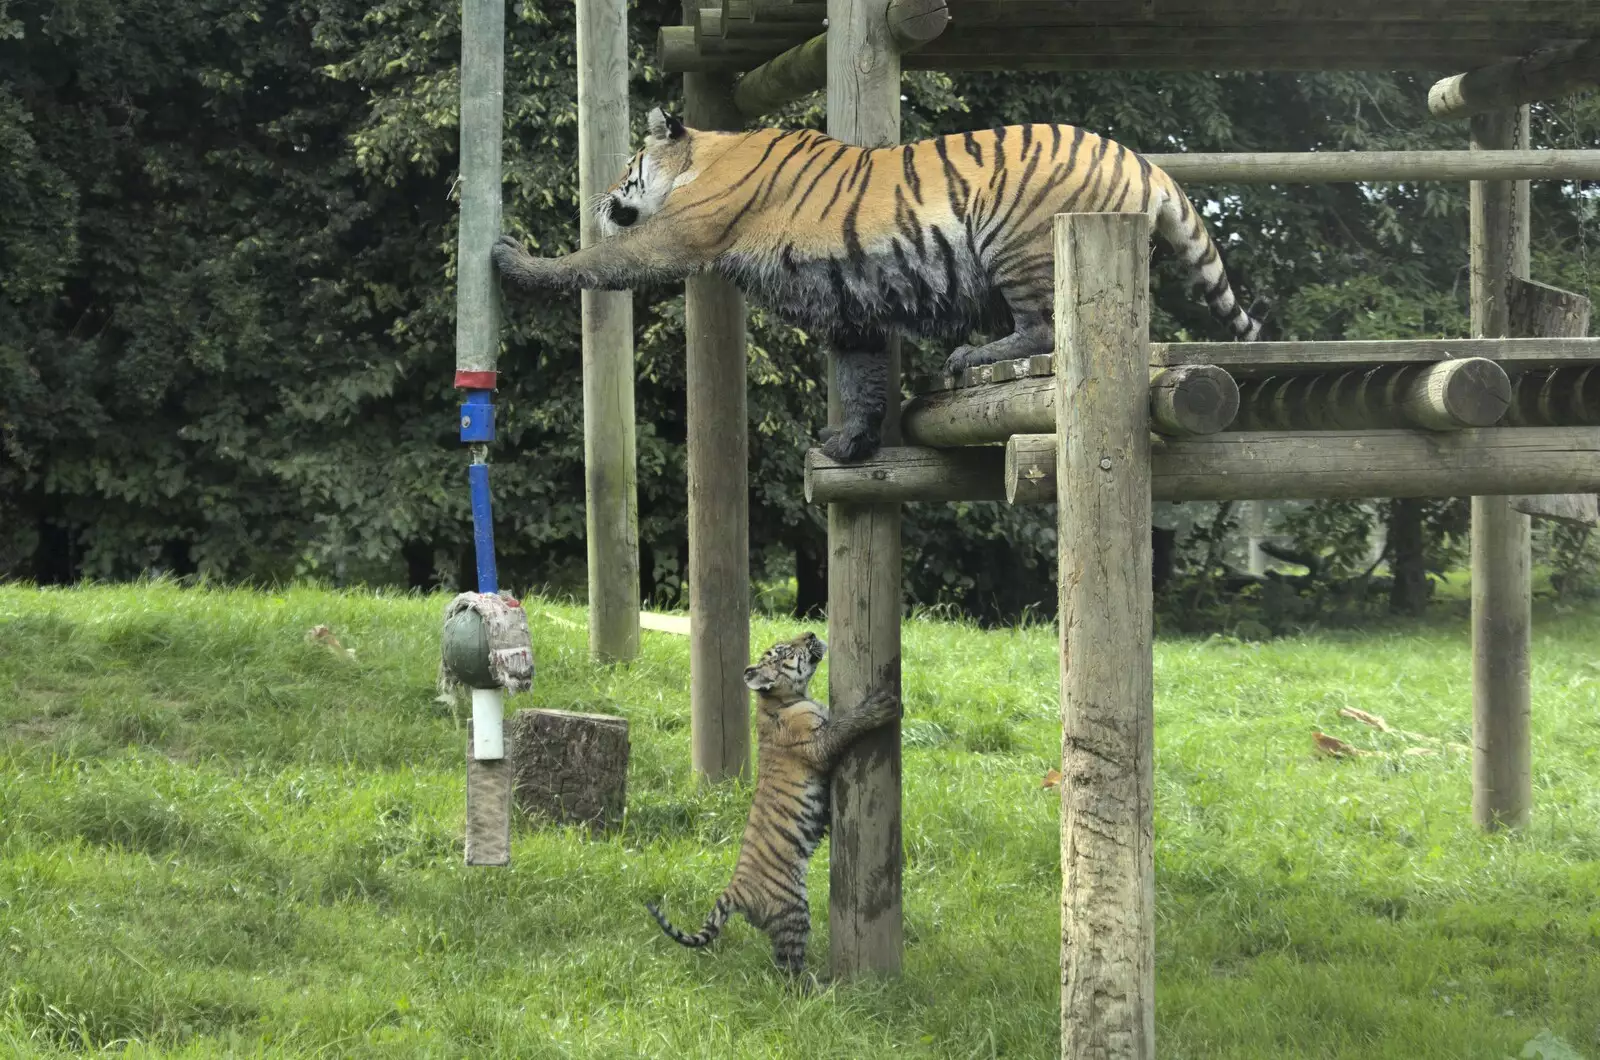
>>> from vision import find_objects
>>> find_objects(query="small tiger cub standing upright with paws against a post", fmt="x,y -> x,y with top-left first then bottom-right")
645,632 -> 901,975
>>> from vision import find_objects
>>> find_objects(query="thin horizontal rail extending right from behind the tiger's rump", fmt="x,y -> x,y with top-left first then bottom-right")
1144,149 -> 1600,184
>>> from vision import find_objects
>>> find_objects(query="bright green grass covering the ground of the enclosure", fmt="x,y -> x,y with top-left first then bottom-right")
0,584 -> 1600,1060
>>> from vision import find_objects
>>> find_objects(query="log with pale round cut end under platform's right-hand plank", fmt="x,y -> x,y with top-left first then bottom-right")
1234,357 -> 1510,431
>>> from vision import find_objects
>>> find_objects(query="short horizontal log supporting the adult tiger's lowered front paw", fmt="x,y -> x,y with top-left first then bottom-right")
805,445 -> 1005,504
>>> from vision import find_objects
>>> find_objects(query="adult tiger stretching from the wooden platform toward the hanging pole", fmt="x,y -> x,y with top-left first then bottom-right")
494,109 -> 1261,461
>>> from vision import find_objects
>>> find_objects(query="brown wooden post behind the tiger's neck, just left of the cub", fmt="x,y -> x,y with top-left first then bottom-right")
683,49 -> 750,781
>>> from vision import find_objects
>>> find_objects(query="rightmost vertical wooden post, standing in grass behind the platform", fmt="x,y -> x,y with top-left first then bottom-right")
1470,107 -> 1533,829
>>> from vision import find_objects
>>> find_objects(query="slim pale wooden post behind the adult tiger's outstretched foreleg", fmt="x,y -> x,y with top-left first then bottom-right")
578,0 -> 638,663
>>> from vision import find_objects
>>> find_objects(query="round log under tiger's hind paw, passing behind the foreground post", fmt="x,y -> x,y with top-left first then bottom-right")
901,365 -> 1238,447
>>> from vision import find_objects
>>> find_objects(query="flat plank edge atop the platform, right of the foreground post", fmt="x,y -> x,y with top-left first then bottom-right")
1150,338 -> 1600,378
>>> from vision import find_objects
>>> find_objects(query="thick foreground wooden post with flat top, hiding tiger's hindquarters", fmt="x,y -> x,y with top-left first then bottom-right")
1054,213 -> 1155,1060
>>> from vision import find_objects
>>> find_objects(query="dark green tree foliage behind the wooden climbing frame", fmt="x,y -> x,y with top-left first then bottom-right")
0,0 -> 1600,618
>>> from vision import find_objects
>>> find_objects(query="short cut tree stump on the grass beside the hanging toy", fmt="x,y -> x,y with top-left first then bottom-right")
506,711 -> 629,831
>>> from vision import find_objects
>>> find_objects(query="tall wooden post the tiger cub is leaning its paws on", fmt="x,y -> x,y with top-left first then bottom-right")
827,0 -> 908,978
